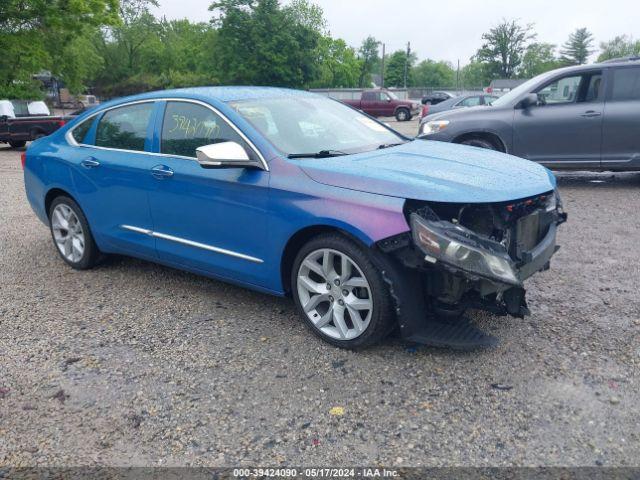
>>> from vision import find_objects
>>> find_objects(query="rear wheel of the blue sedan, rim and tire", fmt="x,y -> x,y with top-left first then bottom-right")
49,196 -> 101,270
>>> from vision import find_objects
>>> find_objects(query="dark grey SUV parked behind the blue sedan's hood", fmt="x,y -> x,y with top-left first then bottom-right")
418,58 -> 640,170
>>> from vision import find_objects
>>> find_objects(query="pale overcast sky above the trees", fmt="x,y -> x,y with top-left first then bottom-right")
158,0 -> 640,65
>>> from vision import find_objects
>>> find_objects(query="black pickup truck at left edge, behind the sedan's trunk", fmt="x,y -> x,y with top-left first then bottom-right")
0,100 -> 67,148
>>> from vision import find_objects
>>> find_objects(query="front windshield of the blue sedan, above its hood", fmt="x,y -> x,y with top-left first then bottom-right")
229,95 -> 405,155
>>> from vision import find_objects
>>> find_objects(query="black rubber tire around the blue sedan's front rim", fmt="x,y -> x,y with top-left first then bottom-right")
291,233 -> 397,350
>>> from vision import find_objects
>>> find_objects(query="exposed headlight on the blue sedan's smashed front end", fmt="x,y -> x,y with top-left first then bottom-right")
411,213 -> 522,285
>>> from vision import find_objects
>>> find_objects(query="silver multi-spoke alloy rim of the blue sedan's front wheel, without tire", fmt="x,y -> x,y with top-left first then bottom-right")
297,248 -> 373,340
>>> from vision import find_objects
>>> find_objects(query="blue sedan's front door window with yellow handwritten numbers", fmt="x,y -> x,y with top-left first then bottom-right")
160,102 -> 252,158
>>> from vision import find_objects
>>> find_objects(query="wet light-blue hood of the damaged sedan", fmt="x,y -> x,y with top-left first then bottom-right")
291,140 -> 556,203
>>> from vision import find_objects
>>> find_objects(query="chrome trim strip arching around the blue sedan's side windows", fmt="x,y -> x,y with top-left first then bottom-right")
65,97 -> 269,172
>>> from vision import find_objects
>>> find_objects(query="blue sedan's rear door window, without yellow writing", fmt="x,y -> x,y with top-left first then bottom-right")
96,103 -> 153,151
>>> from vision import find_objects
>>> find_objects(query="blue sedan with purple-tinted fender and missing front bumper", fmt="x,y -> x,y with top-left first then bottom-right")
23,87 -> 565,348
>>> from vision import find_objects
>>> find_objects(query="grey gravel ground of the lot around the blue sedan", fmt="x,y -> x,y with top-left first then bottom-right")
0,132 -> 640,466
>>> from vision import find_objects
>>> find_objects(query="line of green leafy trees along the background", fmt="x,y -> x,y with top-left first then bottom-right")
0,0 -> 640,98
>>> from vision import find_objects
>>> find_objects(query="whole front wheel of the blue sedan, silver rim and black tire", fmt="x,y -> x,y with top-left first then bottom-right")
291,234 -> 394,349
